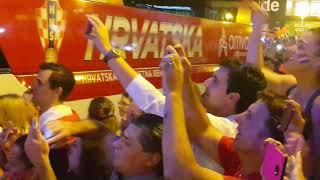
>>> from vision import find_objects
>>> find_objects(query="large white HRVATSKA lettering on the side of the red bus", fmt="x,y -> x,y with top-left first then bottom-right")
84,16 -> 203,61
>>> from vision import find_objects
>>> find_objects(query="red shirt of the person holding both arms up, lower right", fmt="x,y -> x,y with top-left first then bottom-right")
218,137 -> 262,180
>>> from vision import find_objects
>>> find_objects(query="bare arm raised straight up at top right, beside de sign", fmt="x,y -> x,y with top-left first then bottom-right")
246,0 -> 297,95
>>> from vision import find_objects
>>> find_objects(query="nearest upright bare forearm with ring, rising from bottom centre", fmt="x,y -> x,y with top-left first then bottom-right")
161,46 -> 223,180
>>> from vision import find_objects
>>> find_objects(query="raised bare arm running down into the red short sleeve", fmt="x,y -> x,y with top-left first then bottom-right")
175,45 -> 223,162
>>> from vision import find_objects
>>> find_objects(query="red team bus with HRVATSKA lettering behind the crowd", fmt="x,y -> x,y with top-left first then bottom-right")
0,0 -> 251,117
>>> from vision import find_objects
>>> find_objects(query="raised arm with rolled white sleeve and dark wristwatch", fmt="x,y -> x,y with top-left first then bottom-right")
87,15 -> 165,116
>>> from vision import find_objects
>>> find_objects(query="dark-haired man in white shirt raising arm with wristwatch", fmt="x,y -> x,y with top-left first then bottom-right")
88,15 -> 266,172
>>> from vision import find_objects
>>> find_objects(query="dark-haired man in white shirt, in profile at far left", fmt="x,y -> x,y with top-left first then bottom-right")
32,63 -> 79,139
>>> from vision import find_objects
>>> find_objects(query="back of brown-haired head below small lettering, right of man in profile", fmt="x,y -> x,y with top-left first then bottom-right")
88,97 -> 119,132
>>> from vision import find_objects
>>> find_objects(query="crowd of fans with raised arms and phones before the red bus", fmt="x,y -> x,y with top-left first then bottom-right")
0,1 -> 320,180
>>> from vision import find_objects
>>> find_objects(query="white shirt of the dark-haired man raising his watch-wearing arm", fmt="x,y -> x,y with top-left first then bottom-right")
126,75 -> 237,173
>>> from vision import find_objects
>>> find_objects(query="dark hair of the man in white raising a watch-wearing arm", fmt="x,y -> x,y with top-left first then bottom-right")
220,59 -> 267,114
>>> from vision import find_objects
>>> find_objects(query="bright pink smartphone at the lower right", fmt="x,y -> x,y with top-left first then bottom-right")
261,143 -> 288,180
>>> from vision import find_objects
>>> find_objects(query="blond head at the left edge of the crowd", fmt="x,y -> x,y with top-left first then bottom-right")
0,94 -> 35,133
